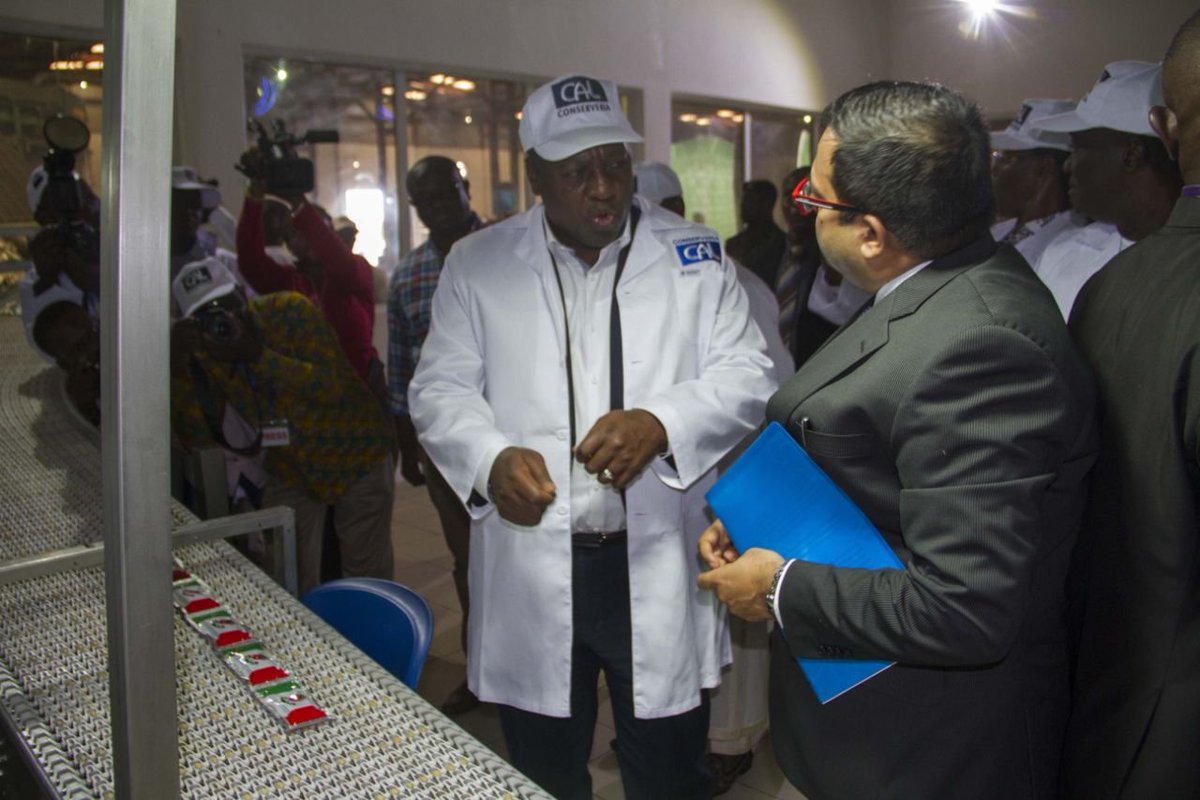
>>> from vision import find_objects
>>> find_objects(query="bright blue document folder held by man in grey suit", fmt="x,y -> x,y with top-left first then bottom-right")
707,422 -> 904,703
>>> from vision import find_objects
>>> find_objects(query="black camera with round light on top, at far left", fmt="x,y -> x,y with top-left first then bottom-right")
41,114 -> 100,264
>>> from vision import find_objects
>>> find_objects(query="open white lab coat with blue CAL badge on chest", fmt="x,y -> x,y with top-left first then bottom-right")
409,198 -> 774,718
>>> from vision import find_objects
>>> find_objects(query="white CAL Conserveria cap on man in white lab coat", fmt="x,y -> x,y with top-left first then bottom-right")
518,76 -> 642,161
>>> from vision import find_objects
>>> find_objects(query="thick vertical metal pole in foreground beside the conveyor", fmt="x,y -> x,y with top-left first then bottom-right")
101,0 -> 179,800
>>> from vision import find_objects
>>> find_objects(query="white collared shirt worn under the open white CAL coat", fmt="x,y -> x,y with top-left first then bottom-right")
544,218 -> 630,533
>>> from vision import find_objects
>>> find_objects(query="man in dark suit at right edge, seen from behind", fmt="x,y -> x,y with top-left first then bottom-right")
1064,13 -> 1200,800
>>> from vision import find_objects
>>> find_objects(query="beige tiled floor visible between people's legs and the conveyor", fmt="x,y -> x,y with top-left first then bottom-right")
391,480 -> 804,800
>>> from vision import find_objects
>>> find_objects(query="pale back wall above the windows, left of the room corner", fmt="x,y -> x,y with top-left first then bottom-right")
0,0 -> 886,205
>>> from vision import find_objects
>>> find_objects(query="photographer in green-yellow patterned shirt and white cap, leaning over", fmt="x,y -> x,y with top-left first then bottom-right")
172,258 -> 395,593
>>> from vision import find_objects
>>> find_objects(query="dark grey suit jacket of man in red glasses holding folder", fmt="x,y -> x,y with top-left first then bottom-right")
767,237 -> 1096,800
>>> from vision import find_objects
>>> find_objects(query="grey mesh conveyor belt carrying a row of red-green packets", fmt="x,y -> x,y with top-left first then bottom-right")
0,318 -> 546,800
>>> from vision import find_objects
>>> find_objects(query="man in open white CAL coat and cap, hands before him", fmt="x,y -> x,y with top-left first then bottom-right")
409,76 -> 774,800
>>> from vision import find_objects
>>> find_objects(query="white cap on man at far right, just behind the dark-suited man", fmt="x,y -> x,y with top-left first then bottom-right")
1038,61 -> 1163,136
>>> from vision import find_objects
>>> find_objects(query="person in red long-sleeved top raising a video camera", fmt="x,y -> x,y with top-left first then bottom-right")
238,138 -> 385,397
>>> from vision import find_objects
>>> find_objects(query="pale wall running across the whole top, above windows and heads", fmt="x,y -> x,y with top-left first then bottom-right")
0,0 -> 1195,195
